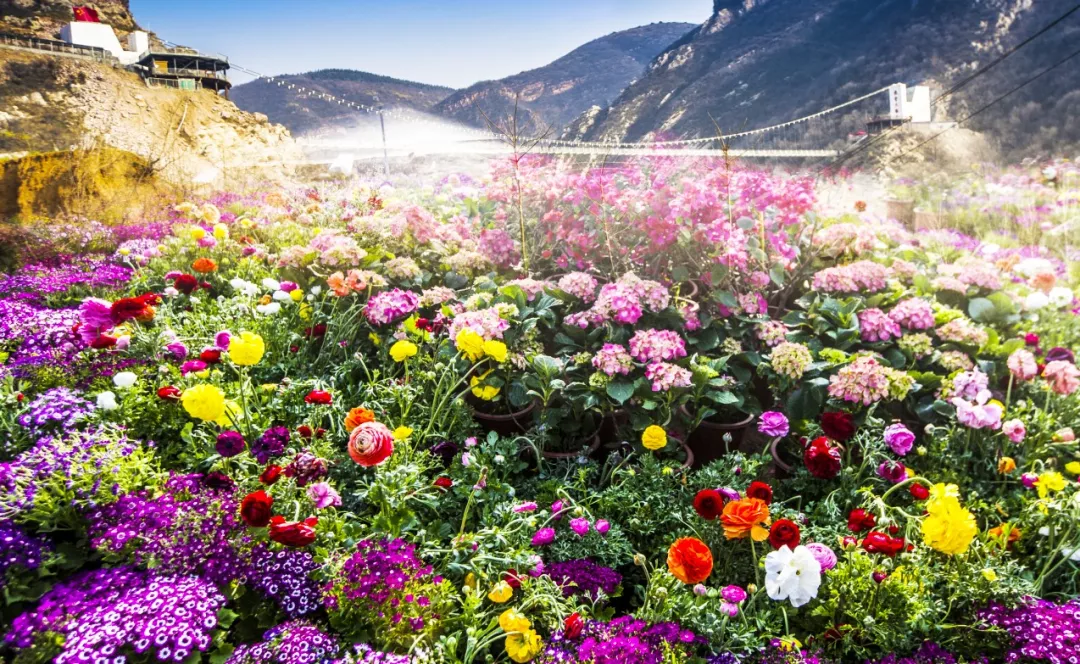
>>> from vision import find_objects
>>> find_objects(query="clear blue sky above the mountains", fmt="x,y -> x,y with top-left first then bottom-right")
131,0 -> 712,87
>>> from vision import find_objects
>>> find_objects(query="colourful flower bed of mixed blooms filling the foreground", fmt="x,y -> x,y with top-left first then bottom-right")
0,159 -> 1080,664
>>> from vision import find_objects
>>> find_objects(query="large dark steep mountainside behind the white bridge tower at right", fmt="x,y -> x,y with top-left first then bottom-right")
573,0 -> 1080,155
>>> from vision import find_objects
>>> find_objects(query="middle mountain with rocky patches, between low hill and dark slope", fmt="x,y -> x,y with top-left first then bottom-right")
435,23 -> 694,133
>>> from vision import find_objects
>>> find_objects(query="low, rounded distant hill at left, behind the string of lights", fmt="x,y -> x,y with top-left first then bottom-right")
230,69 -> 454,134
